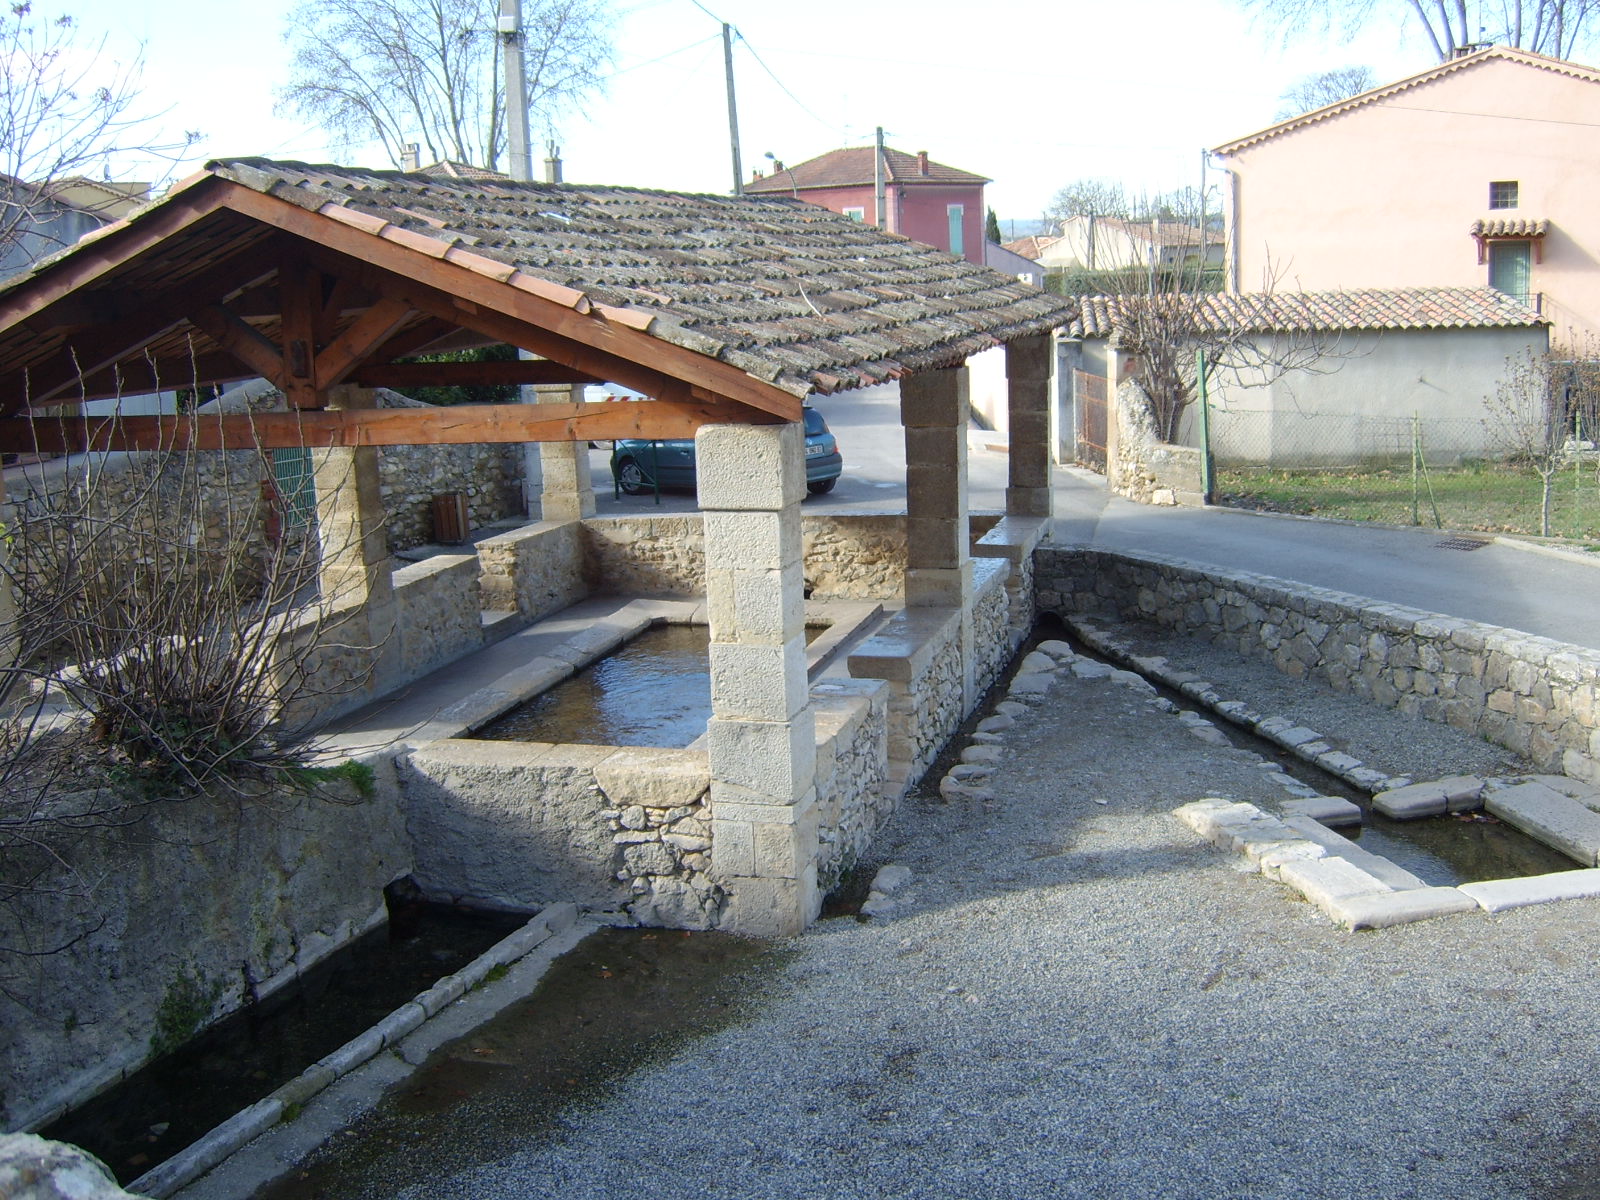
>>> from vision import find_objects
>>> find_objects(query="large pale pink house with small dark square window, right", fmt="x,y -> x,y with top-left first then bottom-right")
1214,46 -> 1600,344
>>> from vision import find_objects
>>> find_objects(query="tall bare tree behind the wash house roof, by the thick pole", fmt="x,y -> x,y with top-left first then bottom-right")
280,0 -> 611,170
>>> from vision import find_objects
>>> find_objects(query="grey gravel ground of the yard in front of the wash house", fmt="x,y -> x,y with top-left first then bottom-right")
268,643 -> 1600,1200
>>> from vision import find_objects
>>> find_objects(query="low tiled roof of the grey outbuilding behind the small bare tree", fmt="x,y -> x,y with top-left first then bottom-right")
1069,288 -> 1549,338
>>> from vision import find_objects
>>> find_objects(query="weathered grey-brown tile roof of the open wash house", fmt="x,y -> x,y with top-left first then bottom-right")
175,158 -> 1075,395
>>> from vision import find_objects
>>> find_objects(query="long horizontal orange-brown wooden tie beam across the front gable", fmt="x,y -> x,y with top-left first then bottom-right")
0,400 -> 761,453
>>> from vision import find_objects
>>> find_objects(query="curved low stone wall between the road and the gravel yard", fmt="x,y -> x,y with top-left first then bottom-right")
1035,549 -> 1600,782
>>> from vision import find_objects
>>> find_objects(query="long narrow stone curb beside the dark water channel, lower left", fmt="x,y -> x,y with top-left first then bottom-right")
128,902 -> 578,1200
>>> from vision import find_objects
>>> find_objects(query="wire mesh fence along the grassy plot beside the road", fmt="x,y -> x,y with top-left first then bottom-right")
1211,411 -> 1600,539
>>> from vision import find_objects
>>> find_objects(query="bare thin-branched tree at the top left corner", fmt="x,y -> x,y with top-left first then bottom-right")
0,0 -> 200,274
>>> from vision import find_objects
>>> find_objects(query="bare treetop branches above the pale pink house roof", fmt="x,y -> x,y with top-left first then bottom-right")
1240,0 -> 1600,62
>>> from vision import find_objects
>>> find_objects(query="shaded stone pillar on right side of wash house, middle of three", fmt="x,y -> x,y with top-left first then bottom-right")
901,366 -> 972,707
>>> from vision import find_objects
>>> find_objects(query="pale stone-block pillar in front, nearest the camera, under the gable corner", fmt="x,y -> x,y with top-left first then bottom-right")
694,424 -> 822,938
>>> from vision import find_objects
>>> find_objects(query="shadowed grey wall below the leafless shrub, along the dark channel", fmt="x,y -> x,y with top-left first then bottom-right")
0,763 -> 411,1128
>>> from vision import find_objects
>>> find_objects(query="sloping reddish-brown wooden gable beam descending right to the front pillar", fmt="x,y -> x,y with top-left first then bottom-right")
219,187 -> 802,421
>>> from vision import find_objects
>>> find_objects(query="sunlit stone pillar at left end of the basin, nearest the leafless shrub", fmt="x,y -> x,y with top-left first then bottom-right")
312,387 -> 394,627
